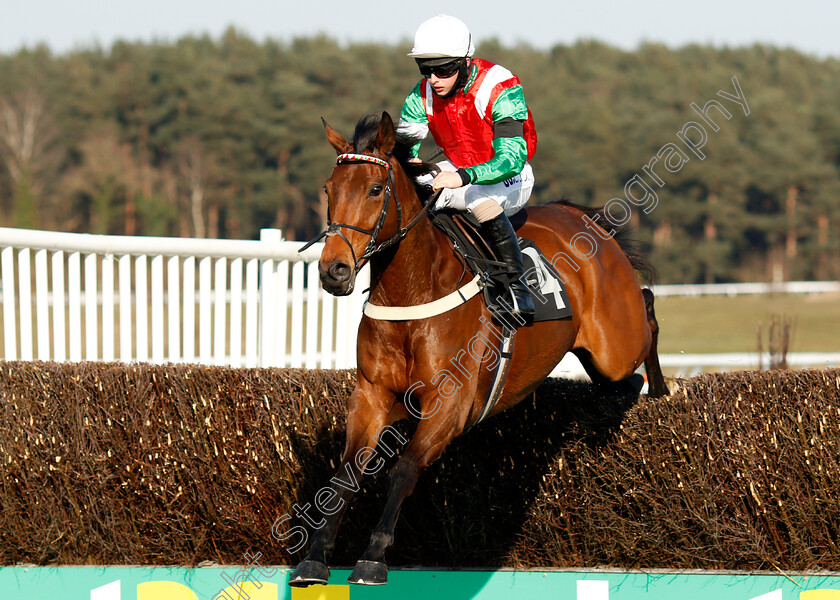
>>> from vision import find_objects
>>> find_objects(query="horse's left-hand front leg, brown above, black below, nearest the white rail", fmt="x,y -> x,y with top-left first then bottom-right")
289,382 -> 394,587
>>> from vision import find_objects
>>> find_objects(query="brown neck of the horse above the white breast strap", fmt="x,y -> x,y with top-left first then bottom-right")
370,206 -> 462,306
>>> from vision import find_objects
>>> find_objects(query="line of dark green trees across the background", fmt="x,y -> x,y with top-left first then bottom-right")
0,29 -> 840,283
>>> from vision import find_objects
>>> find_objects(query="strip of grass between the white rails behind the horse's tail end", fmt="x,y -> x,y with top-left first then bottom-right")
656,294 -> 840,354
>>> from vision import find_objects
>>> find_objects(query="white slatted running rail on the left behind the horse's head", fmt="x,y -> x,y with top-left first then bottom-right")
0,228 -> 368,368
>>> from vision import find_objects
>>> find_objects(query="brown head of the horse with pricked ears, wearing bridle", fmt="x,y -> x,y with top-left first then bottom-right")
316,112 -> 405,296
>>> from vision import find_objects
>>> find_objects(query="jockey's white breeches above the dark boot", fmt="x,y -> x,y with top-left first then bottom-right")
435,161 -> 534,216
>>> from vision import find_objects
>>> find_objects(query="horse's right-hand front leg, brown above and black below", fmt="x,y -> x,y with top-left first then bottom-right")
347,399 -> 465,585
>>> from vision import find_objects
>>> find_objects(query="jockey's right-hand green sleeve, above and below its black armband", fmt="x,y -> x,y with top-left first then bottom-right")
462,85 -> 528,185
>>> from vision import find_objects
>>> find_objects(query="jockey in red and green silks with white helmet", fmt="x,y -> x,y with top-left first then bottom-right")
397,15 -> 537,318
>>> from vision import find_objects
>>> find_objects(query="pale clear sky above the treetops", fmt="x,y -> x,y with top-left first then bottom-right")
0,0 -> 840,58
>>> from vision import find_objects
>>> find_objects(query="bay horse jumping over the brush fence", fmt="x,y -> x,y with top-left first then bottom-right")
289,112 -> 668,587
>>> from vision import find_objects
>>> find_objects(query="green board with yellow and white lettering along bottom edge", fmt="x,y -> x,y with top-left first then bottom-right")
0,567 -> 840,600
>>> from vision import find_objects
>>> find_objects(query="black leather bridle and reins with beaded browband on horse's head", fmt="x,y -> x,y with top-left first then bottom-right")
298,153 -> 440,273
